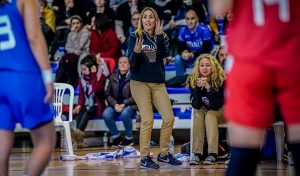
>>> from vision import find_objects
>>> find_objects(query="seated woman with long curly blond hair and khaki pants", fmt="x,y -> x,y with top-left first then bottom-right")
186,54 -> 224,165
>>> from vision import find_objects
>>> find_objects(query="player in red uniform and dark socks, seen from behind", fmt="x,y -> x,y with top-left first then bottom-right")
210,0 -> 300,176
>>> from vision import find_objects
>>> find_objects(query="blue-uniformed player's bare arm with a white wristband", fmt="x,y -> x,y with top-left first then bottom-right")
18,0 -> 53,102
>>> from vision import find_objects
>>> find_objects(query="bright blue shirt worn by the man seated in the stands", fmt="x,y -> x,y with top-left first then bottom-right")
178,23 -> 211,52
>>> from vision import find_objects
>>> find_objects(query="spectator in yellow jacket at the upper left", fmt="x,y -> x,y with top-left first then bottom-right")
39,0 -> 56,47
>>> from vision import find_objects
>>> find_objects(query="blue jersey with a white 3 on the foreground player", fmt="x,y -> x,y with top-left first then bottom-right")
0,0 -> 40,72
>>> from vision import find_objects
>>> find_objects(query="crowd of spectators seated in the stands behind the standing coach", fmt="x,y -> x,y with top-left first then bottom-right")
39,0 -> 231,145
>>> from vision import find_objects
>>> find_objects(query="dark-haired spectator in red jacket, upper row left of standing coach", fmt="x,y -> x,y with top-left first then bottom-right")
90,13 -> 122,73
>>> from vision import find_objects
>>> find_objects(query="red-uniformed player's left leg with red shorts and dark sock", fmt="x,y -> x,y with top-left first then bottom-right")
225,62 -> 275,176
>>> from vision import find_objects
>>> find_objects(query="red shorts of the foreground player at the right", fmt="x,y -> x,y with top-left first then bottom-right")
225,56 -> 300,128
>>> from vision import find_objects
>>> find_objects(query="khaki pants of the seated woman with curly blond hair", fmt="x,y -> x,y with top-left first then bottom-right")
192,107 -> 225,154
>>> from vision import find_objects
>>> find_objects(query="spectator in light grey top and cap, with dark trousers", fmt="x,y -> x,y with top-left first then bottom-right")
55,15 -> 90,86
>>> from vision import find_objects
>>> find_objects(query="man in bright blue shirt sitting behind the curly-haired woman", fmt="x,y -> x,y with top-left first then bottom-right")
175,9 -> 212,76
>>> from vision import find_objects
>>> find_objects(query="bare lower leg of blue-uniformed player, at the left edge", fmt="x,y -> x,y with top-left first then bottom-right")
0,130 -> 14,176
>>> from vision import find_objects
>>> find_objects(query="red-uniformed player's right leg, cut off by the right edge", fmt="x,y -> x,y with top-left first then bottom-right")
276,66 -> 300,175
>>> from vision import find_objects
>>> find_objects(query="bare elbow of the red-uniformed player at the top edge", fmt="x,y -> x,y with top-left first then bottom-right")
209,0 -> 234,17
